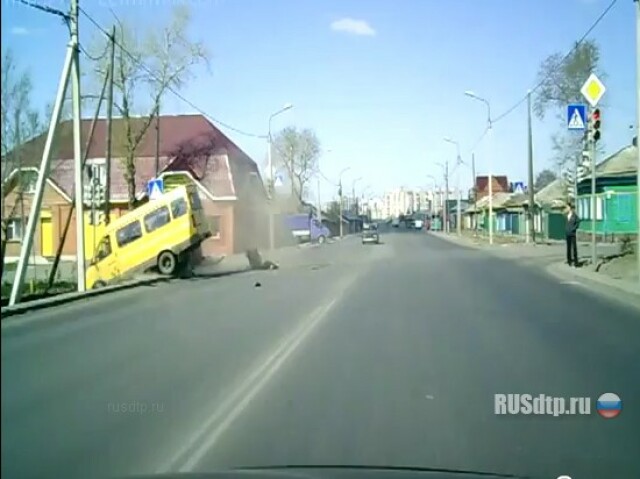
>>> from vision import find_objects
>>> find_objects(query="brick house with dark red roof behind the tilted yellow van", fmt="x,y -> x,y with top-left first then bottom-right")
3,115 -> 268,257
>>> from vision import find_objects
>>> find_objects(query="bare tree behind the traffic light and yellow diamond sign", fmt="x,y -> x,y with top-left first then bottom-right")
533,40 -> 605,170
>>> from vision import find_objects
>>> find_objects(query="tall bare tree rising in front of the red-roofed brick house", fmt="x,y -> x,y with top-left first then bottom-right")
90,5 -> 209,208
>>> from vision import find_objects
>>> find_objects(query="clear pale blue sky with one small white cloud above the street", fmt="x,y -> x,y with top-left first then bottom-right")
1,0 -> 637,201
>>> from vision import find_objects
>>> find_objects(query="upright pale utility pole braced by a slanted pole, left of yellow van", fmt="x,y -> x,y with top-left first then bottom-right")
70,0 -> 85,292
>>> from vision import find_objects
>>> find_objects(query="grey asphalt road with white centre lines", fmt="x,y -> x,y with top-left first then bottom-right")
1,231 -> 640,479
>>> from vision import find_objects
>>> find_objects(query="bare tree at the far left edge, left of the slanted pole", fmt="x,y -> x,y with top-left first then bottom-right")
0,49 -> 43,270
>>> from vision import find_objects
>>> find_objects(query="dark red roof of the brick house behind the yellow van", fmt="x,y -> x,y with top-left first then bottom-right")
15,115 -> 262,201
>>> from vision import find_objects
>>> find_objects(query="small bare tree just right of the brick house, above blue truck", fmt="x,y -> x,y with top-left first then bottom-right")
274,127 -> 320,204
